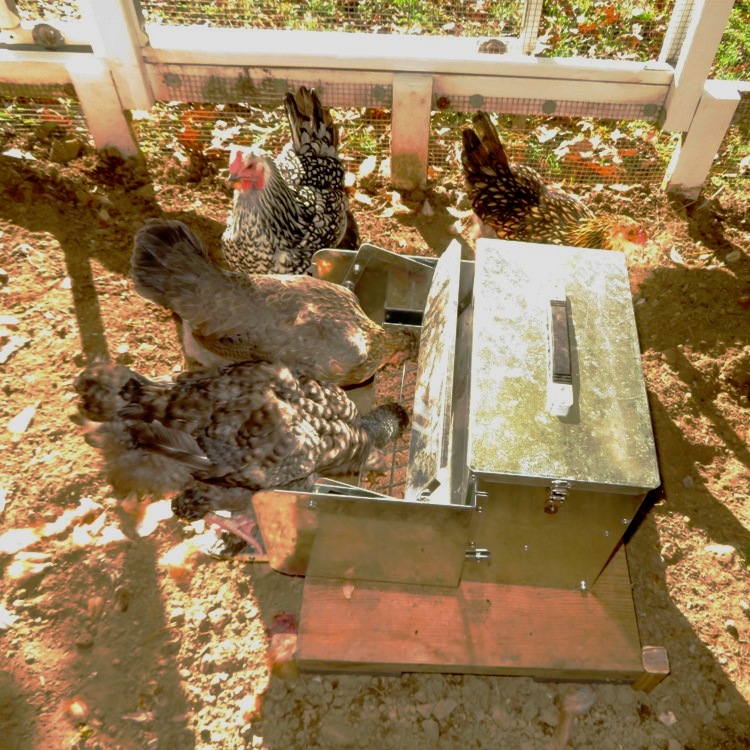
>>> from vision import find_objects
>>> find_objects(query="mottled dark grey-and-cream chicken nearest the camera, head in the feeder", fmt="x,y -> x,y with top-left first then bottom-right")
75,362 -> 409,548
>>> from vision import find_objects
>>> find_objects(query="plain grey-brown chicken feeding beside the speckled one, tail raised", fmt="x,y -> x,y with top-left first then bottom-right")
131,219 -> 415,385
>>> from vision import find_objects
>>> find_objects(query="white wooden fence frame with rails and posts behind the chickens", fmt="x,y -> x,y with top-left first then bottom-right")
0,0 -> 743,196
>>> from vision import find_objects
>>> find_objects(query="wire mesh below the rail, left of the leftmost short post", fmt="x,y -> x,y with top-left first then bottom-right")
0,83 -> 91,149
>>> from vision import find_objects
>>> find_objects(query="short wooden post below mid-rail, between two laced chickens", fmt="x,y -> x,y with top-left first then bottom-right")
391,73 -> 432,190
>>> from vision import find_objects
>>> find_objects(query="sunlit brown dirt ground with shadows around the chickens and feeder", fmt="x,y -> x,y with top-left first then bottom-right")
0,129 -> 750,750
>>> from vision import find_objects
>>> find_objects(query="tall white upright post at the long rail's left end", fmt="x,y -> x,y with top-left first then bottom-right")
78,0 -> 154,109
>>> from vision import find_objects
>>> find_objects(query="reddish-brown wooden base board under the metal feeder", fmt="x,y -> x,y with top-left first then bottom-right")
297,550 -> 644,682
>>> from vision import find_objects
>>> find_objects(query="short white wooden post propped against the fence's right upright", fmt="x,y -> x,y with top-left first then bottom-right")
663,81 -> 740,199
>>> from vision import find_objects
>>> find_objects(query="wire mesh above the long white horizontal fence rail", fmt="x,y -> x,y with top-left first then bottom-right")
135,0 -> 680,61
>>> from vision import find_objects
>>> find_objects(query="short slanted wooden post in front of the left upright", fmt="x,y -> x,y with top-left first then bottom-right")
66,55 -> 138,156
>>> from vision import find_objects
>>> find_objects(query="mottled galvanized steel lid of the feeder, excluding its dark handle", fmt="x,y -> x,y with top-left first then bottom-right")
468,240 -> 659,492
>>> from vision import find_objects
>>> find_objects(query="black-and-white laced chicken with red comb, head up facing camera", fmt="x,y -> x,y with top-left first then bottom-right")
222,86 -> 359,274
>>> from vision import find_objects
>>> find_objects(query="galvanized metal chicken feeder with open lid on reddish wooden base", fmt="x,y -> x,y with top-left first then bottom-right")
253,240 -> 668,689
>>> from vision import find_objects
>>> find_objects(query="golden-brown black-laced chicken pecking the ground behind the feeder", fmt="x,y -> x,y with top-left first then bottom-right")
461,112 -> 646,251
